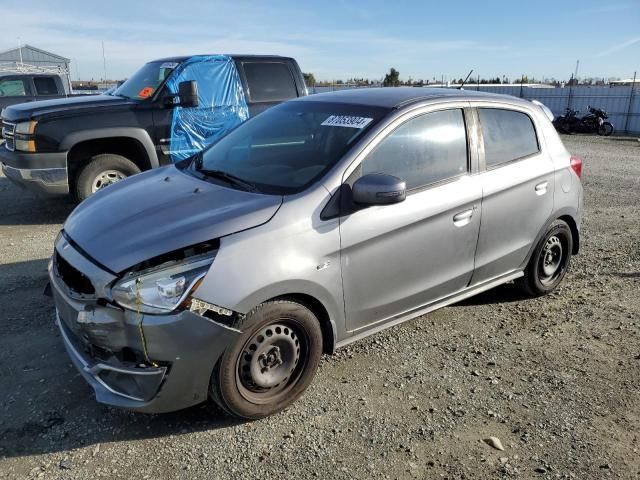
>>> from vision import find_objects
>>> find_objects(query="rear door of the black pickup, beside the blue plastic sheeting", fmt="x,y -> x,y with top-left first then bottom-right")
236,59 -> 304,117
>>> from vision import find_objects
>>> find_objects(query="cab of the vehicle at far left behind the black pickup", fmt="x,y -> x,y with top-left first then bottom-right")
0,72 -> 71,109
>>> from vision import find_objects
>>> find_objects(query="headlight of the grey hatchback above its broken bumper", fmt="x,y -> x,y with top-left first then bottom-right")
111,254 -> 215,313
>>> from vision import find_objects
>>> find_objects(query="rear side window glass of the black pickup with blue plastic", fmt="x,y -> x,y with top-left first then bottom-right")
243,62 -> 298,102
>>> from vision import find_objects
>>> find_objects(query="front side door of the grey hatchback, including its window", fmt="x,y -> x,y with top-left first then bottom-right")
340,105 -> 482,331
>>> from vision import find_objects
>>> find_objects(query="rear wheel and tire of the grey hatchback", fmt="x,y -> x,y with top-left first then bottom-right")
518,220 -> 573,297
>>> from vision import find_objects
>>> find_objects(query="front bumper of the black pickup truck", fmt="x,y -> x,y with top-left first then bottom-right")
0,150 -> 69,195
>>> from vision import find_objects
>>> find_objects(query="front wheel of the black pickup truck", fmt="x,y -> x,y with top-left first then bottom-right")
76,153 -> 140,201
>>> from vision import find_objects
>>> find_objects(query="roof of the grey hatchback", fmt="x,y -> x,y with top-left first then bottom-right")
297,87 -> 520,109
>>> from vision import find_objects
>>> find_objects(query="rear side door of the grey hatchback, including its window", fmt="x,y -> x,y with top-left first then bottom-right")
472,104 -> 555,284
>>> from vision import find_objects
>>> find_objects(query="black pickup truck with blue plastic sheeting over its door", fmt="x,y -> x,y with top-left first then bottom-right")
0,55 -> 307,200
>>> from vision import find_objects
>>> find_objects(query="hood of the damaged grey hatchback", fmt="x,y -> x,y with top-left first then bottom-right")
64,166 -> 282,273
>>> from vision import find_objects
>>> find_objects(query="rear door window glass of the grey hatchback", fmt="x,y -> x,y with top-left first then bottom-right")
478,108 -> 540,168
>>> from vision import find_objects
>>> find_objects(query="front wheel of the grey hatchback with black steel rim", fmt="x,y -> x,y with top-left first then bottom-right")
209,300 -> 322,419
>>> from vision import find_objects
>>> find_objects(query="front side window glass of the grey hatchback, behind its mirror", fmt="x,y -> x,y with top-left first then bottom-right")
359,109 -> 468,190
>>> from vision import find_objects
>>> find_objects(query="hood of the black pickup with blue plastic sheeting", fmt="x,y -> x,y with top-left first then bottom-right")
2,95 -> 136,122
